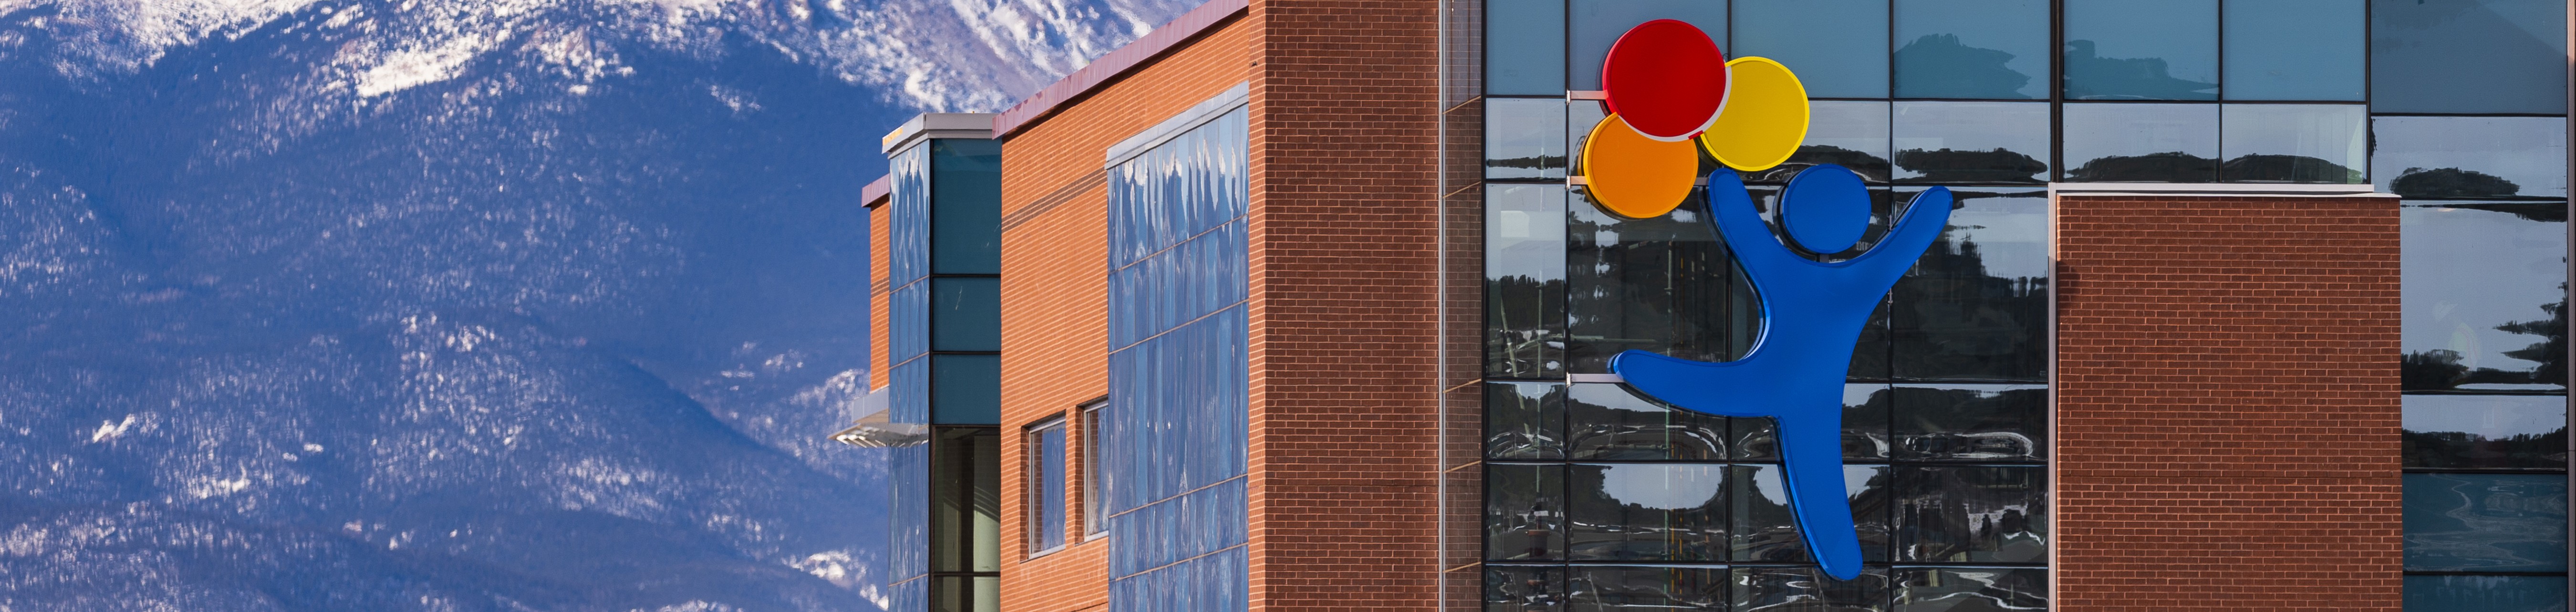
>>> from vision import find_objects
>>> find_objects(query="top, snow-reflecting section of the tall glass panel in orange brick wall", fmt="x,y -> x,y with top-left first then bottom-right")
1108,108 -> 1252,270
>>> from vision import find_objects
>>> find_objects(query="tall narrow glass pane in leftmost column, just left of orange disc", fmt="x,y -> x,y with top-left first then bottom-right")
1484,183 -> 1566,378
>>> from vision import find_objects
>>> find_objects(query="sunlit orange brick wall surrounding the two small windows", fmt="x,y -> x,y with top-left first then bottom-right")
1002,18 -> 1252,612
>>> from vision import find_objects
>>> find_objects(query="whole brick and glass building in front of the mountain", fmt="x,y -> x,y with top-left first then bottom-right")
840,0 -> 2568,612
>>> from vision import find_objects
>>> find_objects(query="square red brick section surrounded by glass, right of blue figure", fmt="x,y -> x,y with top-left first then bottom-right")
2053,196 -> 2403,612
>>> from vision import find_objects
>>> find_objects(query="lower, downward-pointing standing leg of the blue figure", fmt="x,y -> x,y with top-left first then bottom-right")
1777,406 -> 1860,581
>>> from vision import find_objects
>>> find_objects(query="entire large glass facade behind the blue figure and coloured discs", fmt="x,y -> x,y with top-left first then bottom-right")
1448,0 -> 2568,612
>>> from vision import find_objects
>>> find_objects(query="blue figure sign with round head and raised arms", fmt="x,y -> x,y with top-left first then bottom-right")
1610,165 -> 1950,579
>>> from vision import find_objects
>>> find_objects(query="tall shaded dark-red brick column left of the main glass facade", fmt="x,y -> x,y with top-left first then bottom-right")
1249,0 -> 1440,610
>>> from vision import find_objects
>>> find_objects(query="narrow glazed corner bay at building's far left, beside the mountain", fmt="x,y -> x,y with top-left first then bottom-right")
886,139 -> 1002,612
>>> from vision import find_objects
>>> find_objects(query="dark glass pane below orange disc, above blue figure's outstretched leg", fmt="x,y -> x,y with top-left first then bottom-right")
1566,190 -> 1762,373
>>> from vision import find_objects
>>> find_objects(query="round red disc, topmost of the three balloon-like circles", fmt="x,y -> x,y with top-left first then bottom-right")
1602,18 -> 1726,141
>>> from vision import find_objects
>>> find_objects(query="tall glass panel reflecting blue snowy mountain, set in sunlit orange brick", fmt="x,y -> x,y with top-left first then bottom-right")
1100,108 -> 1252,612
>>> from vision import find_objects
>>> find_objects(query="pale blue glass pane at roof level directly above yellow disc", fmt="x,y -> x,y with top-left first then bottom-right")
1728,0 -> 1888,97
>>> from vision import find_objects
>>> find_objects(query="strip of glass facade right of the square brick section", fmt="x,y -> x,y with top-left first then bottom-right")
2370,0 -> 2568,612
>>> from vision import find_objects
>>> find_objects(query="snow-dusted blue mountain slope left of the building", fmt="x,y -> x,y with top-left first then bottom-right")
0,0 -> 1195,612
